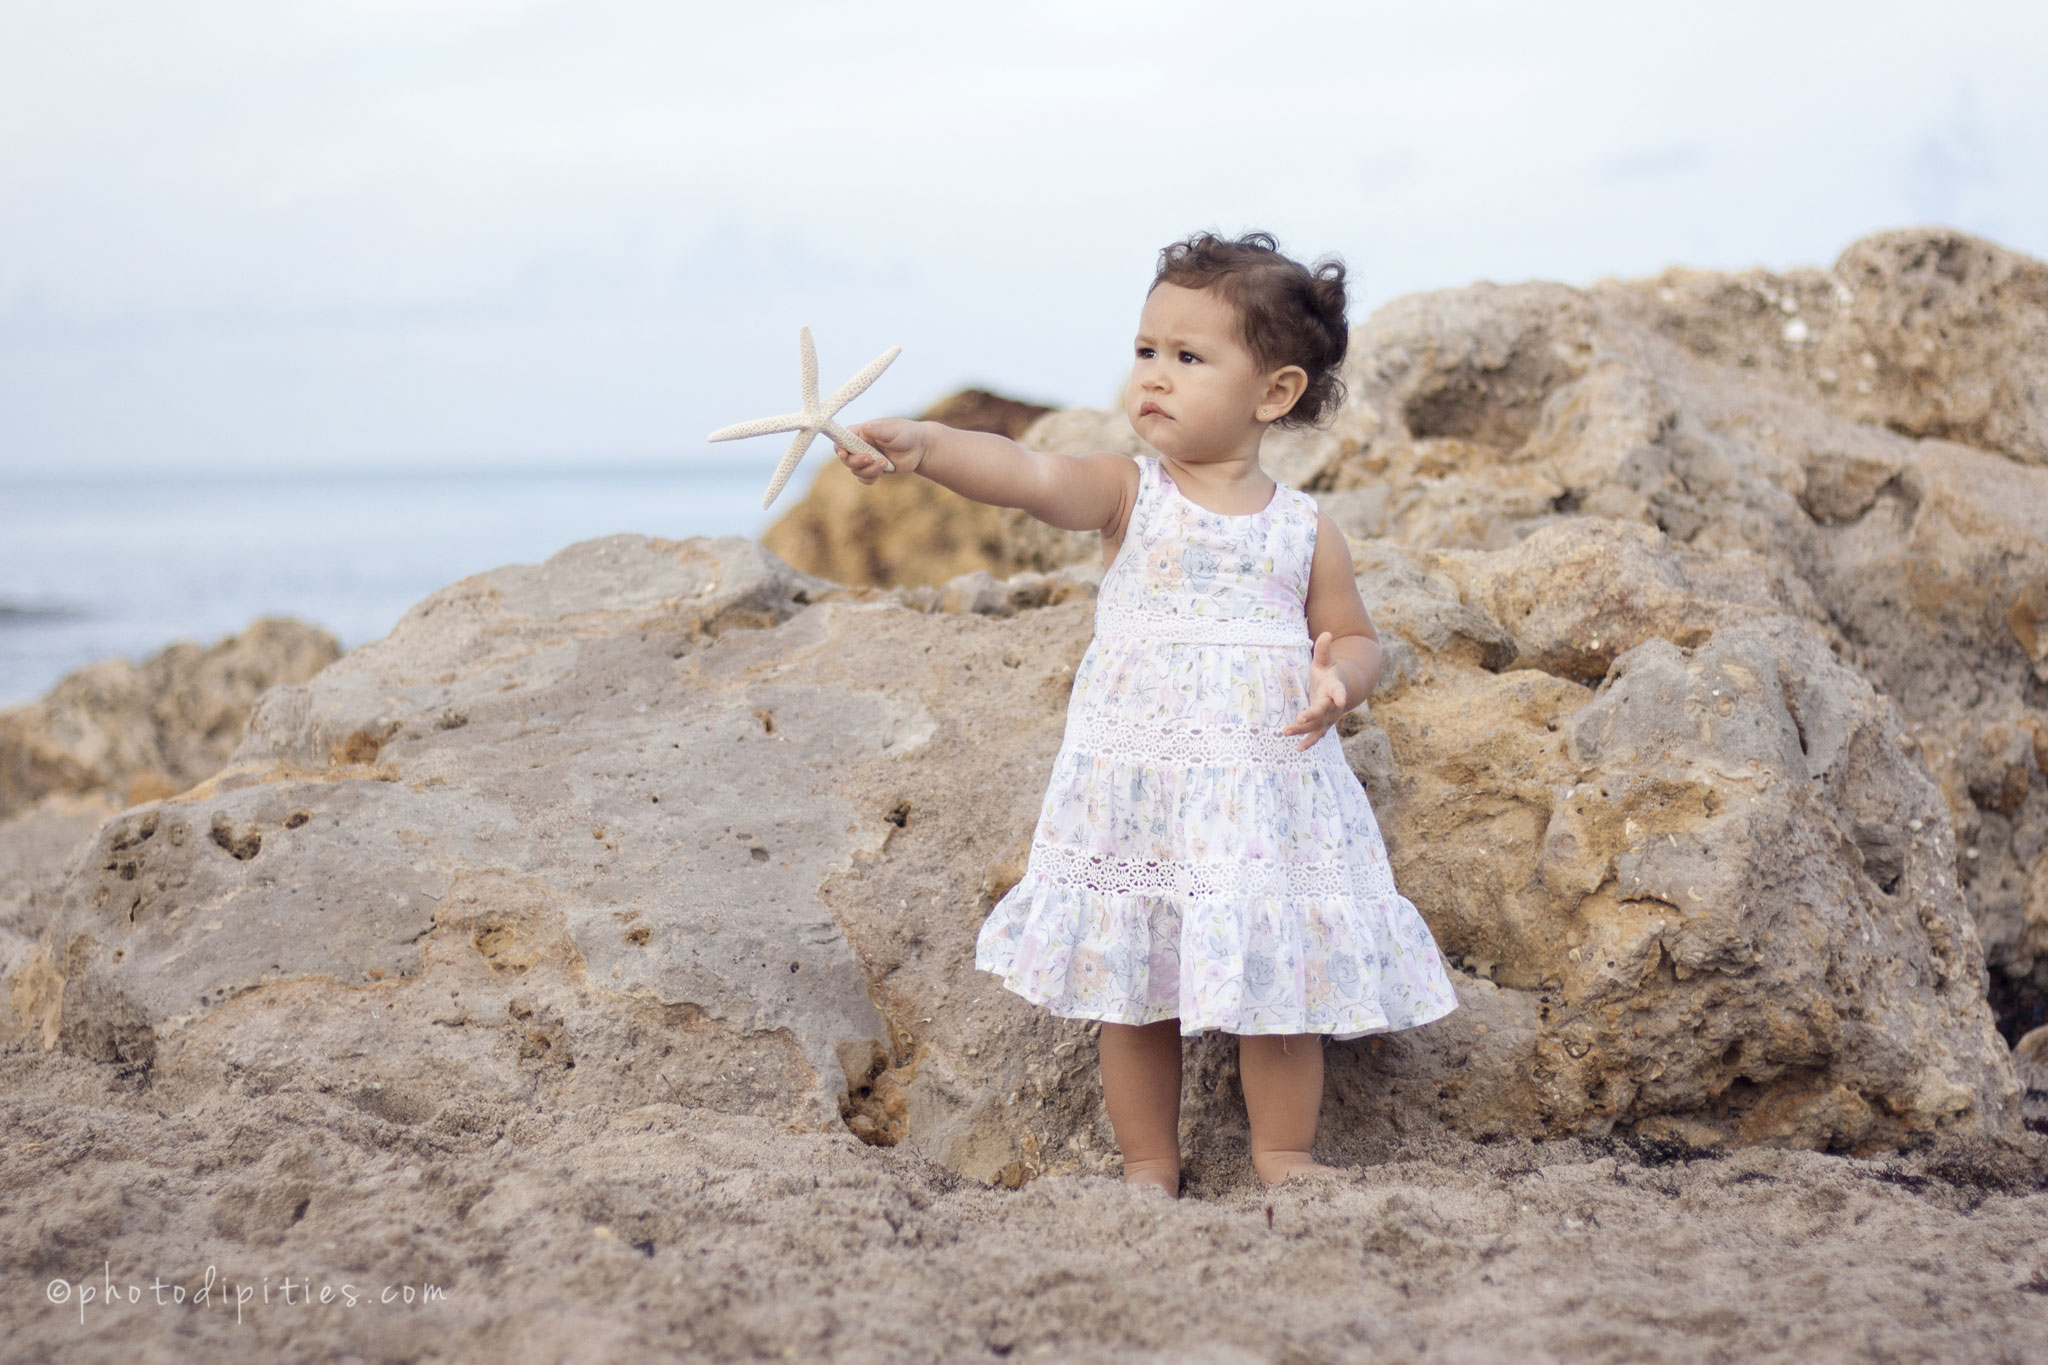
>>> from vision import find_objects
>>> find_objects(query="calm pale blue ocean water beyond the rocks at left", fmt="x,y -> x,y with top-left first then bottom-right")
0,458 -> 782,706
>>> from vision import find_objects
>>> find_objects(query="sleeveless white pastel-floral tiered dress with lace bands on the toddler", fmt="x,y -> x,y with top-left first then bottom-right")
975,456 -> 1458,1040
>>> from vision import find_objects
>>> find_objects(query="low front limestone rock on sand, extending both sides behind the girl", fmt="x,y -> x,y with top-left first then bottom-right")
16,520 -> 2015,1181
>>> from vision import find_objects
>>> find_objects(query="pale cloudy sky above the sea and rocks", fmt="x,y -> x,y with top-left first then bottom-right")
0,0 -> 2048,477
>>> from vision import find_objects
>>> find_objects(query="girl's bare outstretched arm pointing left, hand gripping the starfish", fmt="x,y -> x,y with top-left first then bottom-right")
836,417 -> 1130,530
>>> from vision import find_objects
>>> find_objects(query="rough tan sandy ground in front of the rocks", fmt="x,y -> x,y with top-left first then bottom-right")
0,1050 -> 2048,1365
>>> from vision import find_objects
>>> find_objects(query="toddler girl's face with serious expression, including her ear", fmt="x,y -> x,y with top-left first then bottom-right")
1124,284 -> 1307,463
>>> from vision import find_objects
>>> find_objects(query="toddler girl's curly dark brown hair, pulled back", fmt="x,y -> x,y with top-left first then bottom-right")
1145,231 -> 1352,426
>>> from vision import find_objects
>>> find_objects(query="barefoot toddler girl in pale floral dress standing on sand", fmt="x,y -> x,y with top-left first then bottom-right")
840,233 -> 1458,1193
